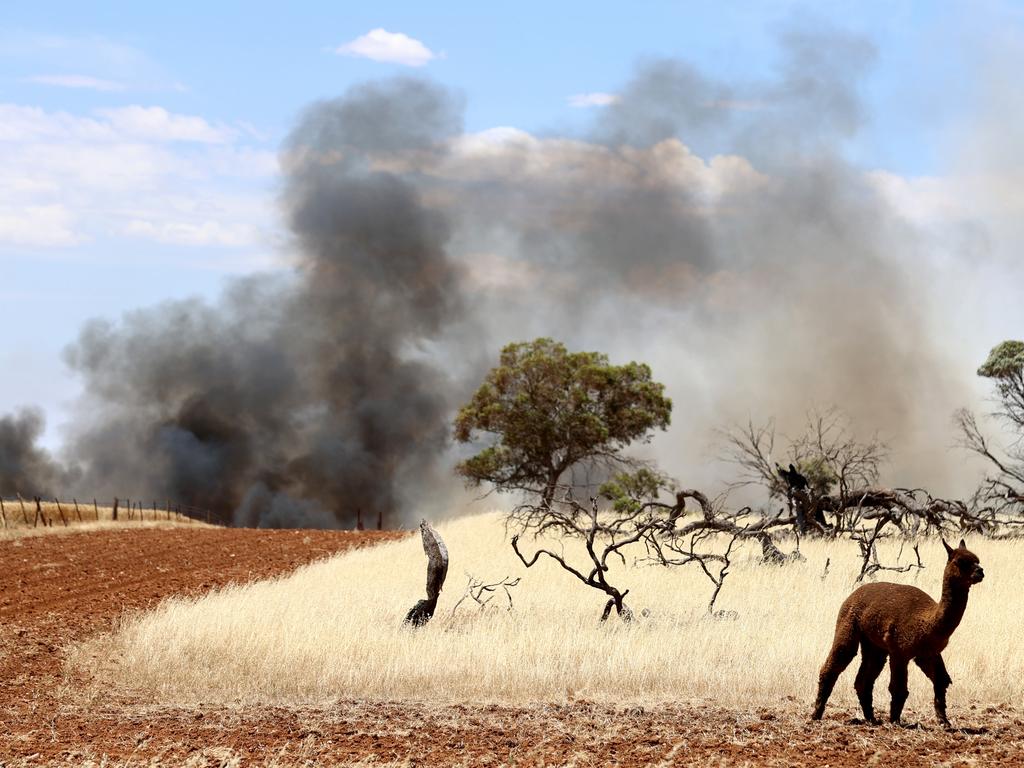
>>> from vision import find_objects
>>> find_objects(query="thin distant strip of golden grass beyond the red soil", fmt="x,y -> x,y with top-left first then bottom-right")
0,500 -> 205,541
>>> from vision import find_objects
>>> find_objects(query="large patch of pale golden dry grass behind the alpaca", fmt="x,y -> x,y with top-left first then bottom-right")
77,514 -> 1024,716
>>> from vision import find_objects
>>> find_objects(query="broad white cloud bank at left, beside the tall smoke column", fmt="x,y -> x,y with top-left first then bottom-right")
0,103 -> 279,252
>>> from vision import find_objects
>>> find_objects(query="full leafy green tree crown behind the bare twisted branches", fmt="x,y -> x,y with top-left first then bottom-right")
455,338 -> 672,506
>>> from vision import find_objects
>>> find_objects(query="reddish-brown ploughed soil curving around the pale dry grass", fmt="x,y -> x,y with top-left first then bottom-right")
0,528 -> 1024,768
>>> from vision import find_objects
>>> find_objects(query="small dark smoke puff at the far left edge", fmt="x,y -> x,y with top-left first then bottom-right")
0,409 -> 74,499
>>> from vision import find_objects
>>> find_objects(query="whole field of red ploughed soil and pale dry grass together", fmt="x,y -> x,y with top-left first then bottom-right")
6,516 -> 1024,768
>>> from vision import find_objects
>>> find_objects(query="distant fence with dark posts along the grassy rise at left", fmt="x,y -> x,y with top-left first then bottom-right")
0,494 -> 225,528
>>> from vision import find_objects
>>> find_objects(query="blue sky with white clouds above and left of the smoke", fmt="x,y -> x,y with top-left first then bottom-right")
0,1 -> 1024,442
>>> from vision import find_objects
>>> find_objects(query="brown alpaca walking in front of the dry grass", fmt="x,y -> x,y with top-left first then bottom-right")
811,539 -> 985,728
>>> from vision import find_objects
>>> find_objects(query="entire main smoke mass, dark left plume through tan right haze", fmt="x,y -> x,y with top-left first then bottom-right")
4,20 -> 987,525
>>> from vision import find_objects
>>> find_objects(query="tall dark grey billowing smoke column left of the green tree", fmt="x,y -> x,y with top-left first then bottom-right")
58,80 -> 462,526
